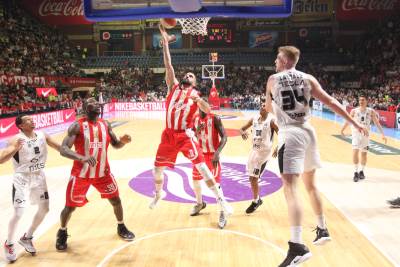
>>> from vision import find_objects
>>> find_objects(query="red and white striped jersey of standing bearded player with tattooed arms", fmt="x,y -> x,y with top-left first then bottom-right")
71,117 -> 110,178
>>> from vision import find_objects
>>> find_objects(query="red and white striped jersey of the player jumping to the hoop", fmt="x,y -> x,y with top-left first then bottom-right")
166,84 -> 198,131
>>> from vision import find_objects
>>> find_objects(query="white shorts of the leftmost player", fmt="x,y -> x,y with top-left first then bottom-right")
12,171 -> 49,208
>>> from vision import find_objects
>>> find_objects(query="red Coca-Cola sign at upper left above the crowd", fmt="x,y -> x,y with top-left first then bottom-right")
22,0 -> 92,25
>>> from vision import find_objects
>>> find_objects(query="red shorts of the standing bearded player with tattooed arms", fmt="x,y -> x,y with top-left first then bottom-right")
65,174 -> 119,207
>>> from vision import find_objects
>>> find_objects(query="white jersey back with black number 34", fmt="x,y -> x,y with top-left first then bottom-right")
272,69 -> 311,128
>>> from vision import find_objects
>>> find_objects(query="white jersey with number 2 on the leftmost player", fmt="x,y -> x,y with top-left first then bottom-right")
12,131 -> 47,173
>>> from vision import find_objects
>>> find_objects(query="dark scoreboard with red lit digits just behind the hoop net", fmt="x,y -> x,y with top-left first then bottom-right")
196,21 -> 235,47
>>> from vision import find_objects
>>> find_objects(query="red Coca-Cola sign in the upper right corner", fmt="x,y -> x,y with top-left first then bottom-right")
336,0 -> 400,20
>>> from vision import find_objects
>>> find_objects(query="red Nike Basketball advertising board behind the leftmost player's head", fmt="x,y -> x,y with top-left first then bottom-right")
0,109 -> 76,139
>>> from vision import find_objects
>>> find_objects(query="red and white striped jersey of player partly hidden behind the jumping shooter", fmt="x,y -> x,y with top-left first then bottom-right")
194,114 -> 220,153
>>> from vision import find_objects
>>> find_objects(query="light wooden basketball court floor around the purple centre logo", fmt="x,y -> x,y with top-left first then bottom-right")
0,110 -> 400,267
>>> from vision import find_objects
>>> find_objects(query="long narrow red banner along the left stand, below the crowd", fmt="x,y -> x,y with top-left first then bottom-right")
0,74 -> 96,87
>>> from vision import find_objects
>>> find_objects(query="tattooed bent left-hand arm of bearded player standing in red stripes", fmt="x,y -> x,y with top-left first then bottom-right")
60,122 -> 97,166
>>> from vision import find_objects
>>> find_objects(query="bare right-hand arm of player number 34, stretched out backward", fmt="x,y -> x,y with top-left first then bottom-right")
308,75 -> 366,135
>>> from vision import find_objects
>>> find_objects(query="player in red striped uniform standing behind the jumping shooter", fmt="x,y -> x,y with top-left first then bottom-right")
190,100 -> 228,228
